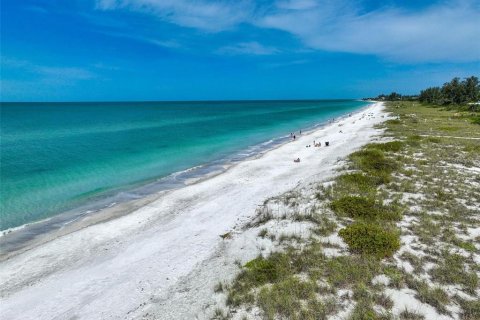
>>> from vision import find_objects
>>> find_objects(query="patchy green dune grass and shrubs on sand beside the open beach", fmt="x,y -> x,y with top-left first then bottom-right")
212,102 -> 480,319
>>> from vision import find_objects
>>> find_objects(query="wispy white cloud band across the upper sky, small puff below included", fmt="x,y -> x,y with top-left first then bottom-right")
96,0 -> 480,63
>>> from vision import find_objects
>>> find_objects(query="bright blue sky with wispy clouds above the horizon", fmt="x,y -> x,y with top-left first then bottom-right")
0,0 -> 480,101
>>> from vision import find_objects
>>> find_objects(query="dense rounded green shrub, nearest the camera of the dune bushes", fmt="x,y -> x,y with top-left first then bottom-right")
338,222 -> 400,258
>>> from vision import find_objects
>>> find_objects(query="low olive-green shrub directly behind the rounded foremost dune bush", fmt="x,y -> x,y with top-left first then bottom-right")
330,196 -> 401,220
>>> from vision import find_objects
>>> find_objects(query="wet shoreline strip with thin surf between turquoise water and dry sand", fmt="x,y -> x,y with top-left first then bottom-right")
0,101 -> 374,262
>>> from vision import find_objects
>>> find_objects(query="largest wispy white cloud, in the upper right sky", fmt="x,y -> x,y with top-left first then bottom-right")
258,2 -> 480,62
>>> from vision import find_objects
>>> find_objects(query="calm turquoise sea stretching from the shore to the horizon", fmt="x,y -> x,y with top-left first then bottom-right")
0,100 -> 365,230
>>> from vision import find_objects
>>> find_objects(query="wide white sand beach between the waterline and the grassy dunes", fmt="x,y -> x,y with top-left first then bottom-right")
0,103 -> 386,320
